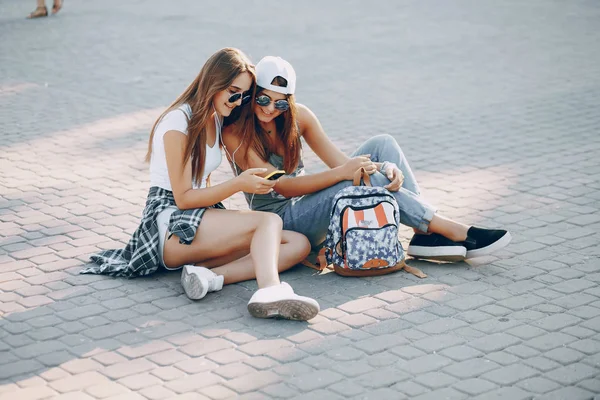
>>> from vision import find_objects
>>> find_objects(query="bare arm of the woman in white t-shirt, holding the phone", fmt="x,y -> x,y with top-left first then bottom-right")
163,131 -> 275,210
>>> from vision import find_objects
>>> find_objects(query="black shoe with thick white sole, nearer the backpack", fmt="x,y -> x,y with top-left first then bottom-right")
406,233 -> 467,262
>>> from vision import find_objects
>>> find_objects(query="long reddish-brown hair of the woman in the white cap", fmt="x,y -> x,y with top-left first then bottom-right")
234,76 -> 302,174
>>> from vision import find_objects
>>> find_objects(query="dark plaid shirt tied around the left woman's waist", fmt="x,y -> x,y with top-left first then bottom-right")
80,186 -> 220,278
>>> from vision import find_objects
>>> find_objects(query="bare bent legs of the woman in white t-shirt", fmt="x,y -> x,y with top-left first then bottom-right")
164,210 -> 310,288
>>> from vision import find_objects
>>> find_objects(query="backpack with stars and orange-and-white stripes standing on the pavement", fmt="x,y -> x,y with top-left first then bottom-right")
309,169 -> 427,278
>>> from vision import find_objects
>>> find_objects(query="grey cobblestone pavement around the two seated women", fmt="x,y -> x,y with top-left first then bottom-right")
0,0 -> 600,400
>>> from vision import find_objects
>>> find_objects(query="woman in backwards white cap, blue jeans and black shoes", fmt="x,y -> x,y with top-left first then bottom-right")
223,56 -> 511,261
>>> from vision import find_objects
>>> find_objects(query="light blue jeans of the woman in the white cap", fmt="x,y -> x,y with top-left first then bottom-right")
281,135 -> 435,247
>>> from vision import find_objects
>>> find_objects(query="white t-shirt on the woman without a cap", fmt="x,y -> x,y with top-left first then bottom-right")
150,104 -> 221,191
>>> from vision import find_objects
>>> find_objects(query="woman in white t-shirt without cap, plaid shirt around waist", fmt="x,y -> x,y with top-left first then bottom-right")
82,48 -> 319,320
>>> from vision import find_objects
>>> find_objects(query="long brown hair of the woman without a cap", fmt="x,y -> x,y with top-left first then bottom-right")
146,47 -> 256,183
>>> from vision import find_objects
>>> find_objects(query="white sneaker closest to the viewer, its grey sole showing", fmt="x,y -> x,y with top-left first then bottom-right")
248,282 -> 320,321
